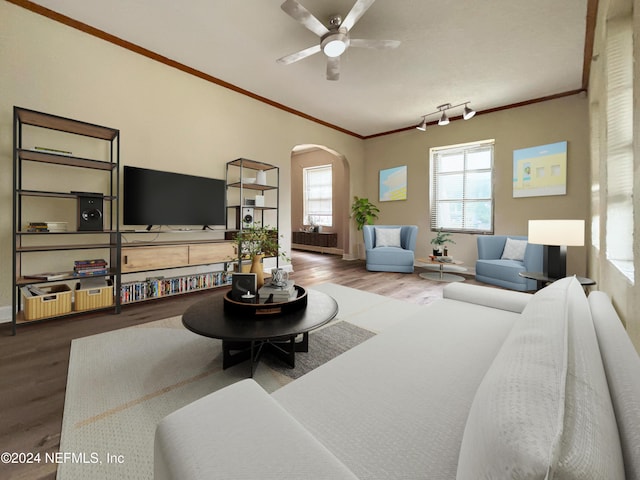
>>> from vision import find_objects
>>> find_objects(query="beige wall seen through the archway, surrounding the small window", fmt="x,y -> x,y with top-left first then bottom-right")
291,148 -> 351,252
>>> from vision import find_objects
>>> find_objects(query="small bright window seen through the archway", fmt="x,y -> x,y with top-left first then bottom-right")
302,165 -> 333,227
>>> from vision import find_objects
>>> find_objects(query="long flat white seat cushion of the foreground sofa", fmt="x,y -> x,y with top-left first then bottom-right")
273,300 -> 520,480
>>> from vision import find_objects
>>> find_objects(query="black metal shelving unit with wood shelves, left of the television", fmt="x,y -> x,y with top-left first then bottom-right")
12,106 -> 121,335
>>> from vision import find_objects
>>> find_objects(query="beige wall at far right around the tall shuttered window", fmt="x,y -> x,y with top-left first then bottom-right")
589,0 -> 640,352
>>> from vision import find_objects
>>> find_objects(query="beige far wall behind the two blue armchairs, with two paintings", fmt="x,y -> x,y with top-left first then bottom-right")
365,95 -> 589,275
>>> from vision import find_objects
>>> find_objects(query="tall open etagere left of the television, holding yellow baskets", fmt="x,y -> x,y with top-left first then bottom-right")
12,106 -> 120,335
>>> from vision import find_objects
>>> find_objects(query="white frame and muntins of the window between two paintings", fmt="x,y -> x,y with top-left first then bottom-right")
429,139 -> 495,234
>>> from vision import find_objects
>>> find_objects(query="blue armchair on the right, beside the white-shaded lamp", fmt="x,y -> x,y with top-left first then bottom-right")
476,235 -> 544,291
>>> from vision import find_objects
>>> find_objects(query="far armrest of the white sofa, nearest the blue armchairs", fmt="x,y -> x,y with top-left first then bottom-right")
442,283 -> 533,313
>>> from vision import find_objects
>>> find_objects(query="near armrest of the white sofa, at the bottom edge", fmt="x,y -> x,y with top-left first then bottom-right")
154,379 -> 356,480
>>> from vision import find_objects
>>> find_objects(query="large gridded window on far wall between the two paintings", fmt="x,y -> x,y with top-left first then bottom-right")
430,140 -> 494,233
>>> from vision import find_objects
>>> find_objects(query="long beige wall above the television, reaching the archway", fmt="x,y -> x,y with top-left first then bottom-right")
0,0 -> 364,312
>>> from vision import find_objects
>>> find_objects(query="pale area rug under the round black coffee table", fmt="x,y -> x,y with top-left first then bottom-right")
57,283 -> 425,480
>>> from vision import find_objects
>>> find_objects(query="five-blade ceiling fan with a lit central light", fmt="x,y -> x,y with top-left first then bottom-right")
277,0 -> 400,80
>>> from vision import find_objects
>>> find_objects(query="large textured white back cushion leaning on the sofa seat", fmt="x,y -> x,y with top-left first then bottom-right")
456,278 -> 624,480
